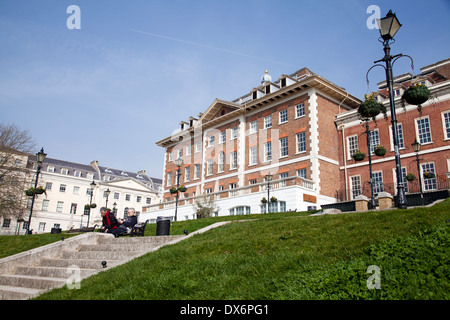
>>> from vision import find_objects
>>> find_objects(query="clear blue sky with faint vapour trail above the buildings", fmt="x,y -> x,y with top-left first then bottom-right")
0,0 -> 450,177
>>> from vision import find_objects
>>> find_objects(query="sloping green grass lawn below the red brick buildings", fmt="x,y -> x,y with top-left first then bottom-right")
27,199 -> 450,300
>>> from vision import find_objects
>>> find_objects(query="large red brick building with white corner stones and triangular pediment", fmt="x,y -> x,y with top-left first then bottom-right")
143,68 -> 360,220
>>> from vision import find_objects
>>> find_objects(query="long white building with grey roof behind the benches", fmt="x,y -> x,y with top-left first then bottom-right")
0,155 -> 161,234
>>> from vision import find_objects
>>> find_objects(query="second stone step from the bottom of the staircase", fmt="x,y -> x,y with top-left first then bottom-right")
0,274 -> 66,290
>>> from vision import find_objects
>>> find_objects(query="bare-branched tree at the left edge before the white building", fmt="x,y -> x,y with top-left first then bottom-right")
0,123 -> 34,219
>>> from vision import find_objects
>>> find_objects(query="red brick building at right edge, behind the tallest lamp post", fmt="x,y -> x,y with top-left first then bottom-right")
336,59 -> 450,201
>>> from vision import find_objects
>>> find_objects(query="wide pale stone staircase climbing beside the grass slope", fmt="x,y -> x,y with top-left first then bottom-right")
0,233 -> 187,300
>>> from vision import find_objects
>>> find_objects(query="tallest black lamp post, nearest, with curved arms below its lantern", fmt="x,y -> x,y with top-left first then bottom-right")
366,10 -> 414,208
